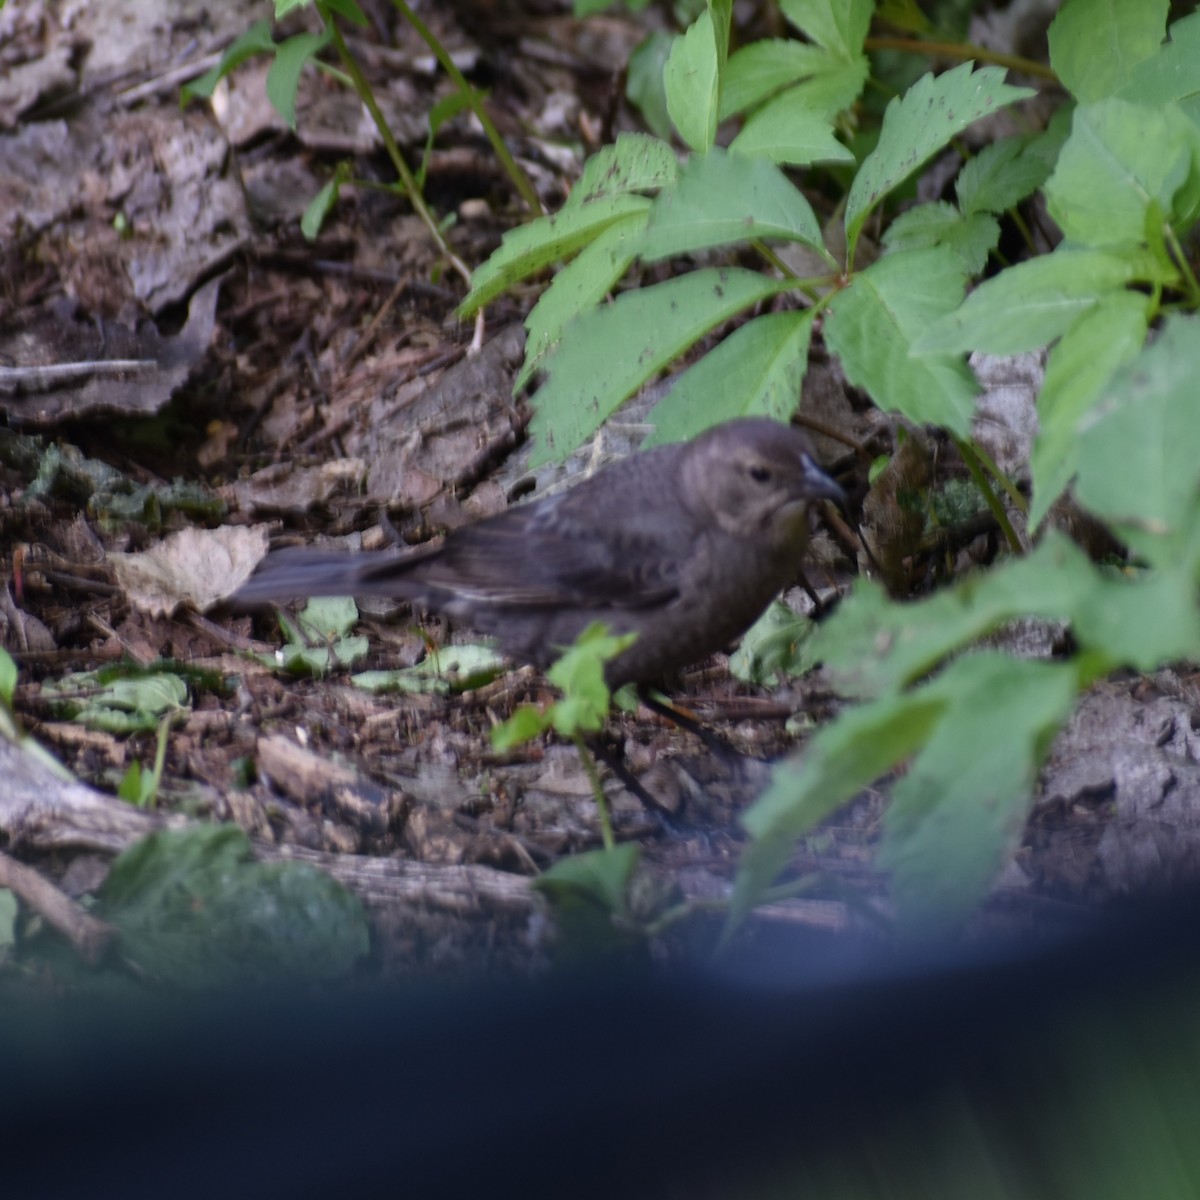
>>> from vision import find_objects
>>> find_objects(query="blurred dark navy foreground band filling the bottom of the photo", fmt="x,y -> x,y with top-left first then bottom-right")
0,893 -> 1200,1200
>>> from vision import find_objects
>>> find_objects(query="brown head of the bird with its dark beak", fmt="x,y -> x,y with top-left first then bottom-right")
683,418 -> 846,544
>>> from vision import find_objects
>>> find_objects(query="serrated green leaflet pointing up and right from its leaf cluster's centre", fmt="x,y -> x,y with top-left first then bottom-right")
846,62 -> 1033,259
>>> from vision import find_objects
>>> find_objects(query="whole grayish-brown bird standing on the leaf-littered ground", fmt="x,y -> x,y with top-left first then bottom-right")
234,418 -> 844,689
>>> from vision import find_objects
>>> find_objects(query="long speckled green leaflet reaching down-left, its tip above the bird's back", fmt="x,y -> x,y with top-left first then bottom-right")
529,268 -> 788,467
